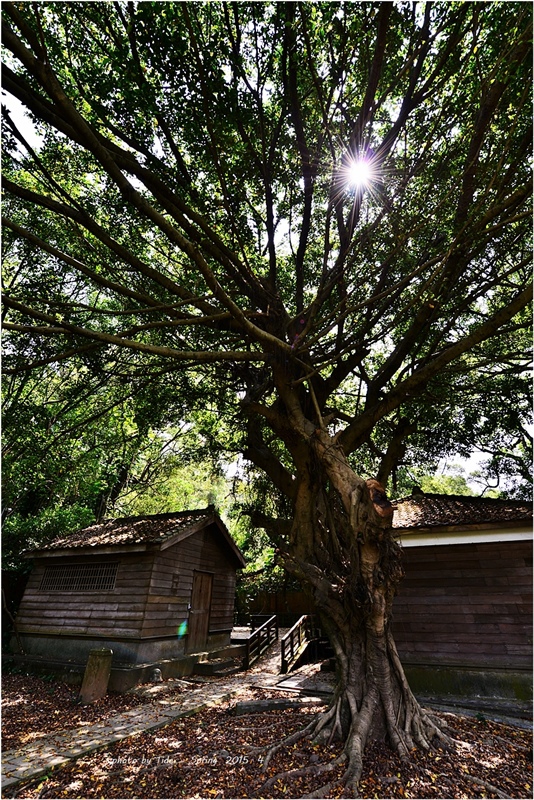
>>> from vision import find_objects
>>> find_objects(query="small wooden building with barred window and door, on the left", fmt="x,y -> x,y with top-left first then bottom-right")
13,508 -> 245,664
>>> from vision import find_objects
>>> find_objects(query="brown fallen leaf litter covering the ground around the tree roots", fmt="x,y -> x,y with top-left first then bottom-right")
3,676 -> 533,800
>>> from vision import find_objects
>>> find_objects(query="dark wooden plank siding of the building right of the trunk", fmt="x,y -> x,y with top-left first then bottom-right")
393,541 -> 532,669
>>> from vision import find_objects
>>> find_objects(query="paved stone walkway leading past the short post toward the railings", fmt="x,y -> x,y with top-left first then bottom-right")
2,671 -> 275,789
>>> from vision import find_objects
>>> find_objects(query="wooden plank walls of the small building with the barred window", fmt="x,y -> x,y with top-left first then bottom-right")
17,526 -> 239,638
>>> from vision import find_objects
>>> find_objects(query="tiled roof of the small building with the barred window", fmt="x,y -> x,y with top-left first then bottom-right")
36,508 -> 218,550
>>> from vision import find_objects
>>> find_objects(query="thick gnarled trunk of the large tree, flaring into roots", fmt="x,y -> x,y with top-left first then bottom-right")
274,430 -> 448,790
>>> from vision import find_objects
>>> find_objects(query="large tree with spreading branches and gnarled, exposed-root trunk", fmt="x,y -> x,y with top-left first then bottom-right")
2,2 -> 531,787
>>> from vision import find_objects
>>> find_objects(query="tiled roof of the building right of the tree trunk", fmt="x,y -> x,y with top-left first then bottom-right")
393,494 -> 532,529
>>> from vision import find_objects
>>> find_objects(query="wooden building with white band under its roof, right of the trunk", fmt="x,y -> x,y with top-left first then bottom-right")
393,492 -> 532,694
